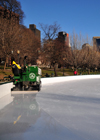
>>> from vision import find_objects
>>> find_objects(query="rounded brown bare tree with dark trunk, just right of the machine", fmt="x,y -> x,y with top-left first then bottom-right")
43,39 -> 68,76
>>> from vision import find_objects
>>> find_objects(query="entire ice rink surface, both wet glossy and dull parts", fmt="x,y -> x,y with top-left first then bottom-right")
0,79 -> 100,140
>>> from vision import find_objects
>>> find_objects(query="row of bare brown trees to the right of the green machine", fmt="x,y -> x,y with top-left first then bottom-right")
40,23 -> 100,76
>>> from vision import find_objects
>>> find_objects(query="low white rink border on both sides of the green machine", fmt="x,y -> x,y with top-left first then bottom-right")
0,75 -> 100,98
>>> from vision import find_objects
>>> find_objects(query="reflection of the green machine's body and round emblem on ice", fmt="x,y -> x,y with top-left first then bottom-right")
12,95 -> 40,120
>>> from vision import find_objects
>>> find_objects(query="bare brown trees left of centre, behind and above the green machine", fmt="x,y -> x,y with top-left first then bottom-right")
0,0 -> 40,70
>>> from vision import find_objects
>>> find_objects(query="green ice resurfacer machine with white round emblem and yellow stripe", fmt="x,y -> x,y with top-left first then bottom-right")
11,56 -> 42,95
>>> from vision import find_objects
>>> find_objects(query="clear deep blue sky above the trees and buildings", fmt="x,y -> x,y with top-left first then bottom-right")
18,0 -> 100,39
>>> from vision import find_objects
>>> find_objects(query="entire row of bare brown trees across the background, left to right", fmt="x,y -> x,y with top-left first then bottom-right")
0,0 -> 100,76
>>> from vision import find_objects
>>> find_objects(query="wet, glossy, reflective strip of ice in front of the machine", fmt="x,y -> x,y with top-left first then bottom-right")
0,95 -> 84,140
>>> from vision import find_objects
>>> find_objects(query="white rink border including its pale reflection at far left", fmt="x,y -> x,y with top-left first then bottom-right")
0,75 -> 100,109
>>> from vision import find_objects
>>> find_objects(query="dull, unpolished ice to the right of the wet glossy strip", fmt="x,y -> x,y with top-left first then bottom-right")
37,79 -> 100,140
